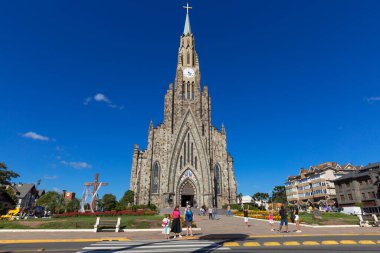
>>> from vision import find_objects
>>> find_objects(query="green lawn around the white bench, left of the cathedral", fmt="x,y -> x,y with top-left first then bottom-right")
0,215 -> 163,229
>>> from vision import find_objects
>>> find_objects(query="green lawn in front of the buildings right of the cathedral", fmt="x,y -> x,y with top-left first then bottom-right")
300,212 -> 359,225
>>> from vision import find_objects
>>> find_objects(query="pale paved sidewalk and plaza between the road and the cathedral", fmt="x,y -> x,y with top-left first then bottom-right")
0,215 -> 380,243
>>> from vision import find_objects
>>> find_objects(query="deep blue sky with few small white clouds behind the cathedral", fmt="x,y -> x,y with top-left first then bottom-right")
0,0 -> 380,200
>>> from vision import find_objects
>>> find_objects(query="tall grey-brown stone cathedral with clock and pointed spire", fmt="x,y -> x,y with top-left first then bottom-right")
130,6 -> 236,207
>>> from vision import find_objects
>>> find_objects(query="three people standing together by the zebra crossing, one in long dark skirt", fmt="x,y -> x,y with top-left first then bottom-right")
162,205 -> 194,240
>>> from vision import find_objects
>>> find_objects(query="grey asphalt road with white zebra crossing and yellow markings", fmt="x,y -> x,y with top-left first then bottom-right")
0,236 -> 380,253
